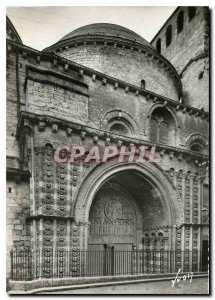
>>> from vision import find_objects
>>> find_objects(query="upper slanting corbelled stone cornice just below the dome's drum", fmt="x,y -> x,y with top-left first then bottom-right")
7,40 -> 209,120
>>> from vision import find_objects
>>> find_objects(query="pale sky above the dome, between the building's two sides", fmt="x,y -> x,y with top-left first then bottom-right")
7,6 -> 176,50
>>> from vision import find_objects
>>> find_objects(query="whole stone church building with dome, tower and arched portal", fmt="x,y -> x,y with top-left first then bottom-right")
7,7 -> 209,280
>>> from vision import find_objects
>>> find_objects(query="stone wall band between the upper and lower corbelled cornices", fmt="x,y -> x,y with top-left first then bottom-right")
16,53 -> 208,147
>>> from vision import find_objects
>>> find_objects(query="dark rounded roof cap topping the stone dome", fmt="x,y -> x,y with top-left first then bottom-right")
58,23 -> 154,49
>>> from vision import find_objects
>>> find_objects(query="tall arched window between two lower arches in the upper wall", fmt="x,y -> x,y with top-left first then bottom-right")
150,107 -> 176,145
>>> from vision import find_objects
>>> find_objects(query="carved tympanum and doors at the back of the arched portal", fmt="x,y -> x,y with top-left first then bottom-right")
86,186 -> 137,276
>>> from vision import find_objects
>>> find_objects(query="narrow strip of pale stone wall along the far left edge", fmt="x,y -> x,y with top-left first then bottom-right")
6,52 -> 31,276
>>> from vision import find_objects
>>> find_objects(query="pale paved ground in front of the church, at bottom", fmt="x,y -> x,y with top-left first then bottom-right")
43,278 -> 208,294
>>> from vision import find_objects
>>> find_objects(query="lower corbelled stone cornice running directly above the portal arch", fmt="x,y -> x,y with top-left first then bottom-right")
16,111 -> 209,160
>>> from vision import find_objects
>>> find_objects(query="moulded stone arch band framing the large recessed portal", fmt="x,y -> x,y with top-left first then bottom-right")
73,161 -> 183,225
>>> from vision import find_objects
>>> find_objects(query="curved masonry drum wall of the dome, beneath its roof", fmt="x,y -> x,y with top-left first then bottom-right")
58,44 -> 178,100
